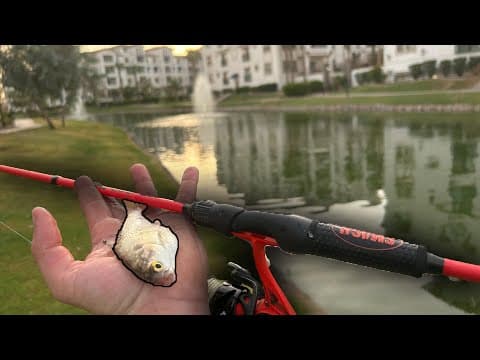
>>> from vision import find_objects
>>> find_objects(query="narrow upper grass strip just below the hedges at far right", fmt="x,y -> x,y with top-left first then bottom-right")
352,77 -> 480,93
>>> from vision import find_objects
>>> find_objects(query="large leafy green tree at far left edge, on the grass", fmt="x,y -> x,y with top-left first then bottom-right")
0,45 -> 80,129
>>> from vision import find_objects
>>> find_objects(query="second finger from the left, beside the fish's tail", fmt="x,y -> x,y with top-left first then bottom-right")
75,176 -> 112,246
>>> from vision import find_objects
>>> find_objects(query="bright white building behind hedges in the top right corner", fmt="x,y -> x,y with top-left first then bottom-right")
383,45 -> 480,82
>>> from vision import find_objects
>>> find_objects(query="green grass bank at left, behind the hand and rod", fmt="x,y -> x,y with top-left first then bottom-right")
0,121 -> 251,314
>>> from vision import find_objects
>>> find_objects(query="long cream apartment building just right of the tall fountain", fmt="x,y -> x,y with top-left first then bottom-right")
201,45 -> 380,91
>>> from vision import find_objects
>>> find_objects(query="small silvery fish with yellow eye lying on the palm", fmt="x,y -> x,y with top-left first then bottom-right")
113,200 -> 178,287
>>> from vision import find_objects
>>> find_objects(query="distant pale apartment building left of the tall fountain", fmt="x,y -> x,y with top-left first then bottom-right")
85,45 -> 198,101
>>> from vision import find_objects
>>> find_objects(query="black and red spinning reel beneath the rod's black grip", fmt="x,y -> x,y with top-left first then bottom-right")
208,262 -> 264,315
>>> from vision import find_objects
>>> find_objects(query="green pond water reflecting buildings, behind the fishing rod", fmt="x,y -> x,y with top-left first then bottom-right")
93,112 -> 480,314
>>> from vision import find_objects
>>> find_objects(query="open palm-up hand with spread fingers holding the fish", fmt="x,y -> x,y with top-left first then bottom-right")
32,164 -> 209,314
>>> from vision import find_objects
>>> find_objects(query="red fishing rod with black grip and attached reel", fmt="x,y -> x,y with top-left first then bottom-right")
0,165 -> 480,315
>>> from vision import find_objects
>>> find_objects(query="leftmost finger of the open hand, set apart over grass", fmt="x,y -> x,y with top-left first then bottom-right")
32,207 -> 74,301
